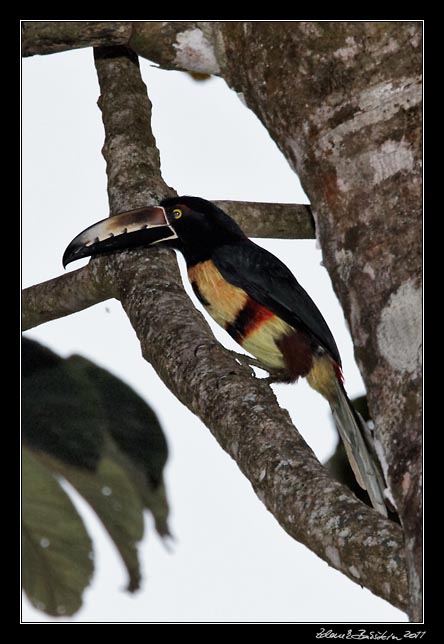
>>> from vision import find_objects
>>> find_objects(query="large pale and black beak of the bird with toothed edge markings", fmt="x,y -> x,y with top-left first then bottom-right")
62,206 -> 177,268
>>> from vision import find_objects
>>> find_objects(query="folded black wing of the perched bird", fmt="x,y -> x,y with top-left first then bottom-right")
211,240 -> 341,365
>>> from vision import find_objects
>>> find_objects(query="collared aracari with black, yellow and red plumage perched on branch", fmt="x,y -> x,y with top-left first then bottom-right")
63,196 -> 387,516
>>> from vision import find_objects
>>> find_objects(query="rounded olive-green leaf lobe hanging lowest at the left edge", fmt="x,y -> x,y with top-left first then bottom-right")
22,448 -> 94,616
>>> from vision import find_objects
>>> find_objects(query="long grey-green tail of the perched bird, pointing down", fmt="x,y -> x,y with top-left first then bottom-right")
329,378 -> 387,516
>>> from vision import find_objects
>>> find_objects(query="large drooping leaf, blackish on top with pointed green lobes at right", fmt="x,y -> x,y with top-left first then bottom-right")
22,339 -> 172,605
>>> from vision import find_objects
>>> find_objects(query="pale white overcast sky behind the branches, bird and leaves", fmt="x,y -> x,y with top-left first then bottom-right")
22,49 -> 406,623
